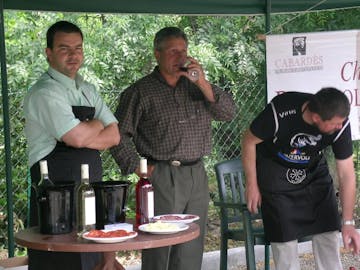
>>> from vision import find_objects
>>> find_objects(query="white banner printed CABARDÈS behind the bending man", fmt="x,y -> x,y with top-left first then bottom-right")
266,30 -> 360,140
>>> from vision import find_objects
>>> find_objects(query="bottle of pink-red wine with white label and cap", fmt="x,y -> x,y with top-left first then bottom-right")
135,158 -> 154,228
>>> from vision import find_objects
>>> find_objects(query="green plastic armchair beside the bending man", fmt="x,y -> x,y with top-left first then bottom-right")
214,159 -> 270,270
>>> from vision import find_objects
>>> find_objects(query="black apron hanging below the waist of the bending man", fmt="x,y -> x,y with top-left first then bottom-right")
257,156 -> 340,242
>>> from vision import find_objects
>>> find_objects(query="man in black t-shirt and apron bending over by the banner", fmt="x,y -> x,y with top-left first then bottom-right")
242,88 -> 360,270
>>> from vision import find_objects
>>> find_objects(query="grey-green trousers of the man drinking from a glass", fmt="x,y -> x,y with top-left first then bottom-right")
141,161 -> 209,270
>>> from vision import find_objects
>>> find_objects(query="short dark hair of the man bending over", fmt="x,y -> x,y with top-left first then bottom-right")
308,87 -> 350,121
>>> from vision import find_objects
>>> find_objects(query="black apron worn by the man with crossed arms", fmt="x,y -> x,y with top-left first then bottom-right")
28,106 -> 102,270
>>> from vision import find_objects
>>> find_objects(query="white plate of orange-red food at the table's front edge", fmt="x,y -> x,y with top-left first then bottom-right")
82,230 -> 137,244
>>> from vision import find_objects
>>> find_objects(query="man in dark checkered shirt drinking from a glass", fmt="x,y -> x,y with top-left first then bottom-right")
111,27 -> 235,270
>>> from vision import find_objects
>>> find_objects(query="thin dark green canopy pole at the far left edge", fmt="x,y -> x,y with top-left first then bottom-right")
0,0 -> 14,257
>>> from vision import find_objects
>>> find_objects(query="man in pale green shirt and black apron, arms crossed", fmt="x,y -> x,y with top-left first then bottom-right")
24,21 -> 120,270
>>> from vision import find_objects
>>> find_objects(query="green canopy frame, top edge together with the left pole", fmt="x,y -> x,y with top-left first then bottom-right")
0,0 -> 360,257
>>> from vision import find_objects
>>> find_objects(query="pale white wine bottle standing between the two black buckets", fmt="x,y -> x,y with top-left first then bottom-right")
76,164 -> 96,235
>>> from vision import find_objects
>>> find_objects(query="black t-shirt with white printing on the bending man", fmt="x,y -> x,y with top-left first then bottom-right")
250,92 -> 352,168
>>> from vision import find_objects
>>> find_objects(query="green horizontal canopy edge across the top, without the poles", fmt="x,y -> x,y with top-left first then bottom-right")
2,0 -> 360,15
